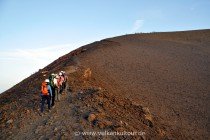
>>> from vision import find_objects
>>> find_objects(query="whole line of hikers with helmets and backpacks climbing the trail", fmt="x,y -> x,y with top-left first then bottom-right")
41,71 -> 68,113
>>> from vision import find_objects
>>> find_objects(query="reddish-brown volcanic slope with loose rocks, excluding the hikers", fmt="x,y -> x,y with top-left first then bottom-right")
0,30 -> 210,139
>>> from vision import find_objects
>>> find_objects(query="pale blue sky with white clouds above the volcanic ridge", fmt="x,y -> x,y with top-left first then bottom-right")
0,0 -> 210,93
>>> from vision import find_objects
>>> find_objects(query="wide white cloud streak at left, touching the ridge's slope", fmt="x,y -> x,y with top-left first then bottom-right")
0,44 -> 72,67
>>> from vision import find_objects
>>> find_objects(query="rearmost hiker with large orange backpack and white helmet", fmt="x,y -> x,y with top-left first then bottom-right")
41,79 -> 52,113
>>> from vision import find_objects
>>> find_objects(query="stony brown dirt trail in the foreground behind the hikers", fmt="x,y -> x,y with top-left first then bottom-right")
2,66 -> 78,139
